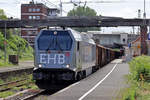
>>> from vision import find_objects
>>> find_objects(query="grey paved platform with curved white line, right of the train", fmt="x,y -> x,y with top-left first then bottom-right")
35,59 -> 129,100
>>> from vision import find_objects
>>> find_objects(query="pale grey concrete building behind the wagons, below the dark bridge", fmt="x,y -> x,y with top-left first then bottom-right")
88,31 -> 139,48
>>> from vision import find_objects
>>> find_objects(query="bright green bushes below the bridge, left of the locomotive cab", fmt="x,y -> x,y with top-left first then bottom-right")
0,33 -> 33,63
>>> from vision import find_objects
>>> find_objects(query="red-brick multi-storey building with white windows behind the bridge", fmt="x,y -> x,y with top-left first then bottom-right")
21,2 -> 60,47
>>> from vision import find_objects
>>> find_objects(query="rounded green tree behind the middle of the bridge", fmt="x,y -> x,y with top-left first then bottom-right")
67,6 -> 100,32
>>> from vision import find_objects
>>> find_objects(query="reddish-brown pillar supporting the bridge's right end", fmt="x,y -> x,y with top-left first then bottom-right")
140,26 -> 147,55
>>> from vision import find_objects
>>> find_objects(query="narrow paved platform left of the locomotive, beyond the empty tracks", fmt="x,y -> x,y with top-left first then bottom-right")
0,61 -> 34,73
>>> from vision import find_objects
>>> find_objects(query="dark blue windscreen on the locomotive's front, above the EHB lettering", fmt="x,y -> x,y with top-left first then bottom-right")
38,30 -> 72,51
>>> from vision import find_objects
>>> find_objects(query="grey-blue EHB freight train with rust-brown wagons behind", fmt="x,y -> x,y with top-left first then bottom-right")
33,28 -> 120,89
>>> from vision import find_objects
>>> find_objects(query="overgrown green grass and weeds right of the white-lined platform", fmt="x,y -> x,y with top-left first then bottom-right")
119,56 -> 150,100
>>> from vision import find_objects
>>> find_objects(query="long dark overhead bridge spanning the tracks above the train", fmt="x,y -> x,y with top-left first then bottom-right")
0,16 -> 150,28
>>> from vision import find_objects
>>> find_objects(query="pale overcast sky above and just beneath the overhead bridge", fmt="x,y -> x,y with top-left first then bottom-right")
0,0 -> 150,32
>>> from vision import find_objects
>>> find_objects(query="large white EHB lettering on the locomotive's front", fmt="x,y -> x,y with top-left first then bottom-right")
40,54 -> 65,64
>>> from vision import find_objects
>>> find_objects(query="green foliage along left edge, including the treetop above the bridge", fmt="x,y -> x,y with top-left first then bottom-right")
0,9 -> 33,66
